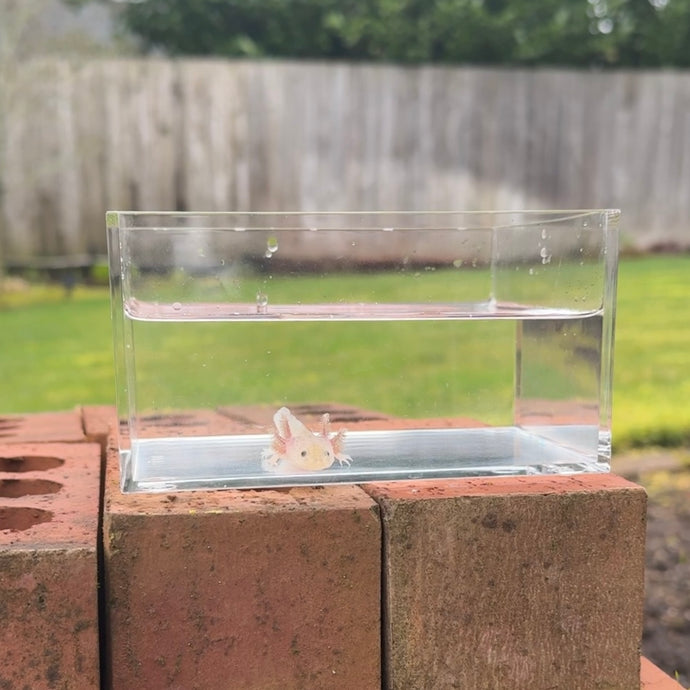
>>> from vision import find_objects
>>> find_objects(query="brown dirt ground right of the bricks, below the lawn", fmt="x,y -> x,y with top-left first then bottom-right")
613,450 -> 690,688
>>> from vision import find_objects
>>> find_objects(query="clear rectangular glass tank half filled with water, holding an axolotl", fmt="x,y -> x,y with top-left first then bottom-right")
107,210 -> 619,492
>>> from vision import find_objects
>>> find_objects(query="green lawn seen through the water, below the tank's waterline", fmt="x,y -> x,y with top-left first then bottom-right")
129,321 -> 515,424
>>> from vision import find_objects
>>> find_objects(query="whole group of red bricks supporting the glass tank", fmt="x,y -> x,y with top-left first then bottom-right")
0,408 -> 680,690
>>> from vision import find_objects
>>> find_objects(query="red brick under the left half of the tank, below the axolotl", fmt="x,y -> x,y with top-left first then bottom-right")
104,438 -> 381,690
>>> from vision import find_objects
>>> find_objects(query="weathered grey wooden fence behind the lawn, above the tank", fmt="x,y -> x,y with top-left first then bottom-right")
0,60 -> 690,260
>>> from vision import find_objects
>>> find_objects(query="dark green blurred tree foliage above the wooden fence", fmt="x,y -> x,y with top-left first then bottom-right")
72,0 -> 690,67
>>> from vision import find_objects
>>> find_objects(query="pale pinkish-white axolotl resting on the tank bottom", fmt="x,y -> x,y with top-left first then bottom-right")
261,407 -> 352,474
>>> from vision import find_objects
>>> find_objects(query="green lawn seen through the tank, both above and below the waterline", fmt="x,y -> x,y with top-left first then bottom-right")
122,269 -> 514,424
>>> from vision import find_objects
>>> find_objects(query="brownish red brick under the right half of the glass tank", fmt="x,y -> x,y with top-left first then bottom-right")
367,474 -> 646,690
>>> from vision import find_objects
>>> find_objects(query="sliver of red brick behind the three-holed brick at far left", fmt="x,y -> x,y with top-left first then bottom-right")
0,411 -> 86,443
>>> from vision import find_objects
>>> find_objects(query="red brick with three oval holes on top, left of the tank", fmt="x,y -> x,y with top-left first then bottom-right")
0,443 -> 100,690
